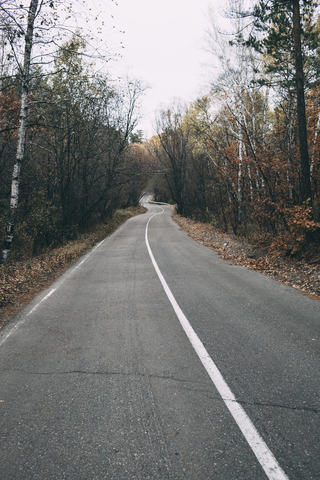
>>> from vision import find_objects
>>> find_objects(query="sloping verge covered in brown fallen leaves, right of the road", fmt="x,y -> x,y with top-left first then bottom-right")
173,215 -> 320,300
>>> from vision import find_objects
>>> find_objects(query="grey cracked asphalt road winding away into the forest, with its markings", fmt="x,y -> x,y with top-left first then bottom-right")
0,201 -> 320,480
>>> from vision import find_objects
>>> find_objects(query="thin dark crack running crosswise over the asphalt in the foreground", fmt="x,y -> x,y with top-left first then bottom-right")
3,368 -> 320,414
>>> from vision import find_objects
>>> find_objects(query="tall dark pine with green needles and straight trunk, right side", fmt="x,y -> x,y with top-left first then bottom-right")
247,0 -> 316,202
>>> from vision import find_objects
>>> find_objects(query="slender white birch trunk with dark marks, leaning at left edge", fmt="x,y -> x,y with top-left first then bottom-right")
2,0 -> 39,264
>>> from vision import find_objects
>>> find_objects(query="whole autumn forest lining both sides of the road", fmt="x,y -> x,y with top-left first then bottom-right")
0,0 -> 320,263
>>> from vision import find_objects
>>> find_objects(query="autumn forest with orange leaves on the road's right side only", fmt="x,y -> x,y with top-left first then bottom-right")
149,1 -> 320,261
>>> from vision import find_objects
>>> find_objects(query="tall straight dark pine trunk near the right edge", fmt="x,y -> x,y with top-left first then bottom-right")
292,0 -> 312,202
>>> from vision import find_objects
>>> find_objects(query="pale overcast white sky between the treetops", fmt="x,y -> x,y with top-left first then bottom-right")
92,0 -> 226,138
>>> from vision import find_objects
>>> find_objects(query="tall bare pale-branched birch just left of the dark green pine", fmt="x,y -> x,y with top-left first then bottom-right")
207,0 -> 268,216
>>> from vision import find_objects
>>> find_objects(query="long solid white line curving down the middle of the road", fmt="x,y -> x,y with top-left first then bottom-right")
145,207 -> 288,480
